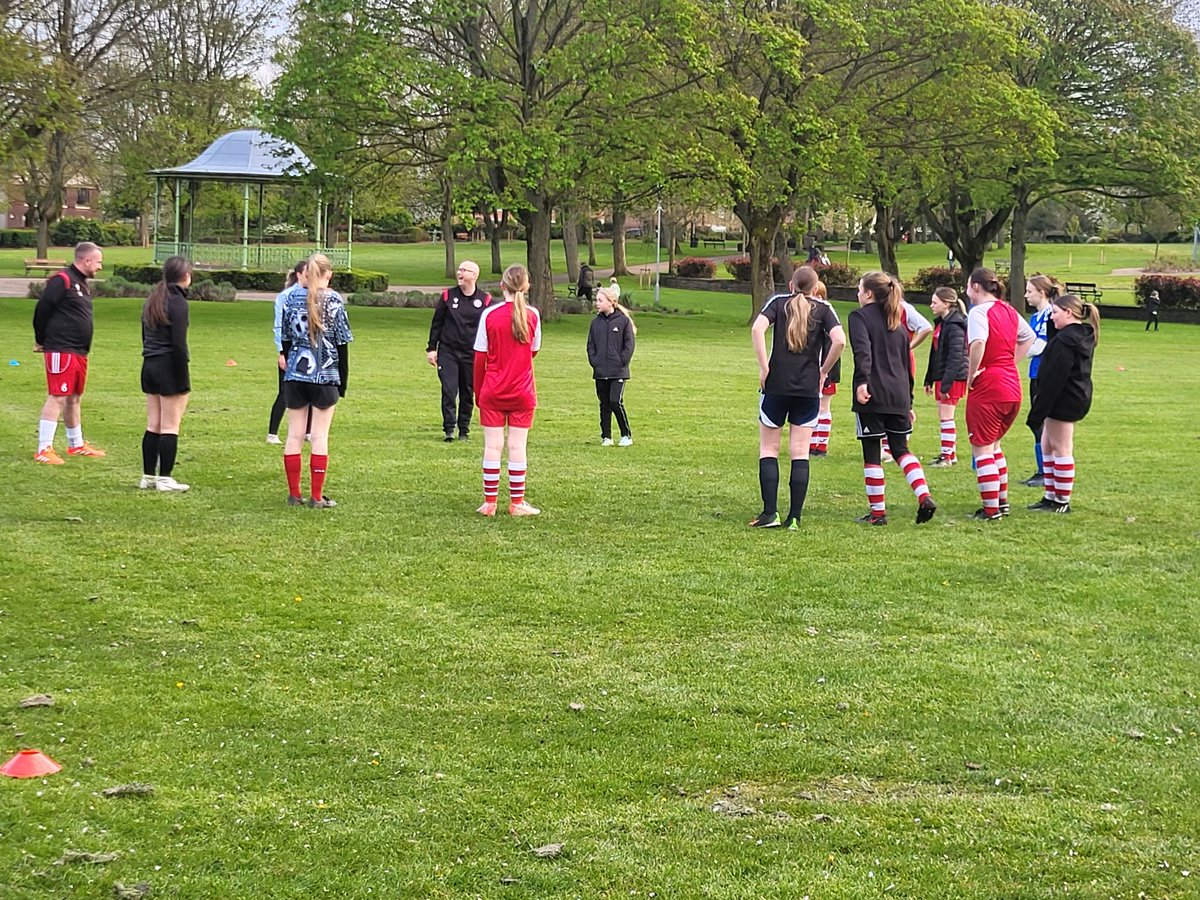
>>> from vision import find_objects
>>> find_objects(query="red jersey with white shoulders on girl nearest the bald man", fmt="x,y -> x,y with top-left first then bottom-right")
475,301 -> 541,413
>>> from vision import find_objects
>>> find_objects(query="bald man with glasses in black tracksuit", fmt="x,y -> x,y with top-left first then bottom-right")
425,259 -> 492,444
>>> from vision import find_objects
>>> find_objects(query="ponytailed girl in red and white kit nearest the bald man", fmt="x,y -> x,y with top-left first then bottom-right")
474,265 -> 541,516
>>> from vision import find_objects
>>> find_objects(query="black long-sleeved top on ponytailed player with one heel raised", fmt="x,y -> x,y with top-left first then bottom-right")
850,304 -> 912,415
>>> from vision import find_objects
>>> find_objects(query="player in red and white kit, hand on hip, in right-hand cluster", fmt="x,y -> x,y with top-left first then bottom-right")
967,269 -> 1034,522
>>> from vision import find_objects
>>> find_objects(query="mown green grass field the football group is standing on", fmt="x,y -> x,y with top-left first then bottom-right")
0,292 -> 1200,900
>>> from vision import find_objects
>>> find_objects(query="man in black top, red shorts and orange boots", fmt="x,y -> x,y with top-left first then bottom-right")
34,241 -> 106,466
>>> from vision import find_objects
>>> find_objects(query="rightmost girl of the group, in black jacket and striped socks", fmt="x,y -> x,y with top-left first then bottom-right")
1028,294 -> 1100,512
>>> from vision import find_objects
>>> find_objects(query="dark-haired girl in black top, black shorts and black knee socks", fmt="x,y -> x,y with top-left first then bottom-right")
138,257 -> 192,493
